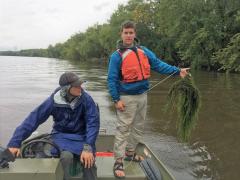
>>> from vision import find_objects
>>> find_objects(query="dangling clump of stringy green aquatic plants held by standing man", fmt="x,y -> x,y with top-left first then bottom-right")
166,75 -> 200,142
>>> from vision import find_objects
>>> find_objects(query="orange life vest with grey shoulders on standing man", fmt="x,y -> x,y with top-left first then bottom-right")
118,48 -> 150,83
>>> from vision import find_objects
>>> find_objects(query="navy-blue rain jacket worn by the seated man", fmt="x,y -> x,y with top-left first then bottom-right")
8,88 -> 100,155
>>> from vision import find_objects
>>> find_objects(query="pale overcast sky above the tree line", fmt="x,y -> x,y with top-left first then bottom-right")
0,0 -> 128,50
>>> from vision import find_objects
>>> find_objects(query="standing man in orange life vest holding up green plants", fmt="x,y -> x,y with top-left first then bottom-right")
108,21 -> 189,178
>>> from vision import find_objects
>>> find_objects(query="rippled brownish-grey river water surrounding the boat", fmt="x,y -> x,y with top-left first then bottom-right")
0,56 -> 240,180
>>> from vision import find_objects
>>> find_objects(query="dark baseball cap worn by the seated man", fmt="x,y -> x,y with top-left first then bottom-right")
59,72 -> 83,87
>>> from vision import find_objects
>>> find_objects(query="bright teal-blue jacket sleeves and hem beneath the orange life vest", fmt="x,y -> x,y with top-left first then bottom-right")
108,46 -> 180,101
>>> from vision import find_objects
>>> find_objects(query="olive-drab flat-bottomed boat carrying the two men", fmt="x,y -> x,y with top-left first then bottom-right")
0,135 -> 174,180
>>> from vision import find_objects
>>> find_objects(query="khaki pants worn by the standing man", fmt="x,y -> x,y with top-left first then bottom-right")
114,94 -> 147,159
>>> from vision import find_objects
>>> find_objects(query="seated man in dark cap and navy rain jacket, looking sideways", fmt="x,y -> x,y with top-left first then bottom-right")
8,72 -> 100,180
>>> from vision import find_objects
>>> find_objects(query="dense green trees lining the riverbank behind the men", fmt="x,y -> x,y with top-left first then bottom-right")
0,0 -> 240,73
